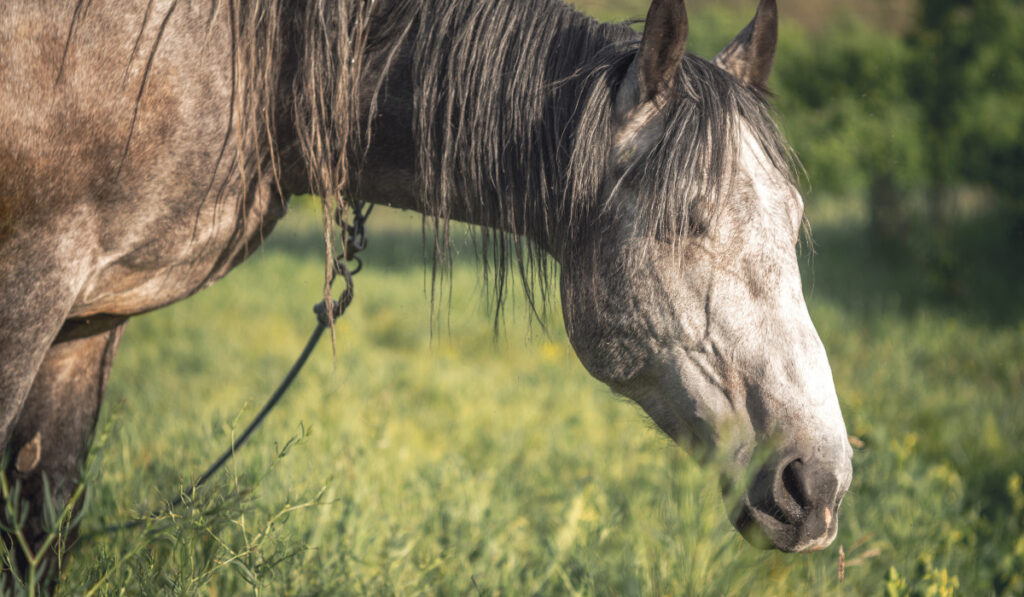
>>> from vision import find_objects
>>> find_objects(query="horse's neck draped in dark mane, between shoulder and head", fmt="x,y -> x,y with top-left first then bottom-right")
351,0 -> 634,257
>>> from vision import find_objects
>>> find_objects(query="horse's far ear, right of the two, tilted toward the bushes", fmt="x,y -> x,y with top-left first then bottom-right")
715,0 -> 778,88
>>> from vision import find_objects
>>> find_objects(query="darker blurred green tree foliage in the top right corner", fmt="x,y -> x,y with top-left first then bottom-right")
907,0 -> 1024,201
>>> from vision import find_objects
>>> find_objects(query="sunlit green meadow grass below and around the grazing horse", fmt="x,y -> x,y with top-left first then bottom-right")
32,194 -> 1024,595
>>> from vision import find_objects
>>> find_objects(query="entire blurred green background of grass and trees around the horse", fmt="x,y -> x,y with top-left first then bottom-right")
63,0 -> 1024,595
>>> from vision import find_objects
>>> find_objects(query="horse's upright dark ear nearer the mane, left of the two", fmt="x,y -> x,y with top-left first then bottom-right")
633,0 -> 689,101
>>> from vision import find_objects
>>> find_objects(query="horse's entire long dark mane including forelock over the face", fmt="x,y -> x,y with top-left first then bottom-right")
230,0 -> 794,323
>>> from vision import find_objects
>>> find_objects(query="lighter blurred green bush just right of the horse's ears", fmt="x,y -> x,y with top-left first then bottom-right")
774,18 -> 928,194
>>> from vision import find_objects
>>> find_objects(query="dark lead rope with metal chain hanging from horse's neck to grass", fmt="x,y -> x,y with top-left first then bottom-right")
78,201 -> 374,543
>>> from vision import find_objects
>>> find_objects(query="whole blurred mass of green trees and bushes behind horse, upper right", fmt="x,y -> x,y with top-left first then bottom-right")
775,0 -> 1024,214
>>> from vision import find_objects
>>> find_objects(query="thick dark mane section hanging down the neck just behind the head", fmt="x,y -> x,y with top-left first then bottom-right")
411,0 -> 634,317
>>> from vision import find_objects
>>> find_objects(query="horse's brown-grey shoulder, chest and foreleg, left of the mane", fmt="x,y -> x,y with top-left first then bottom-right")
0,2 -> 292,565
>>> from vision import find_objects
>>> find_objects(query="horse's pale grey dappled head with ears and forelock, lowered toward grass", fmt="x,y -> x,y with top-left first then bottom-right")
559,0 -> 852,552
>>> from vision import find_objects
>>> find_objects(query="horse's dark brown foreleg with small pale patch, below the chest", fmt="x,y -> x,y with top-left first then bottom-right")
5,324 -> 124,578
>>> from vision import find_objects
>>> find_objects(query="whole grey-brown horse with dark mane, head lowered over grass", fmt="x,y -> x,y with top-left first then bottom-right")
0,0 -> 853,577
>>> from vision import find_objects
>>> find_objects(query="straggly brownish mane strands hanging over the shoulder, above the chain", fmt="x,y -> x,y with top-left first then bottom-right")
226,0 -> 374,321
